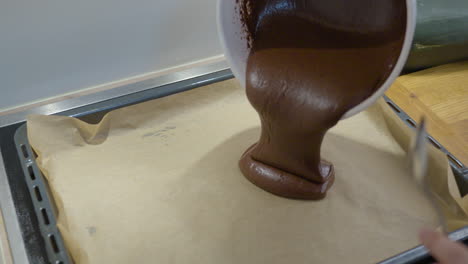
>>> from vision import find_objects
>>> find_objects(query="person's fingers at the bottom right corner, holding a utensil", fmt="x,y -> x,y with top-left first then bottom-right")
419,229 -> 468,264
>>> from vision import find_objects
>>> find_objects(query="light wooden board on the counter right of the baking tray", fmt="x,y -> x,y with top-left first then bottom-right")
386,61 -> 468,166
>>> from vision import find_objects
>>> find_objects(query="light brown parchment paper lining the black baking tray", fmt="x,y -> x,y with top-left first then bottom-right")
28,80 -> 467,264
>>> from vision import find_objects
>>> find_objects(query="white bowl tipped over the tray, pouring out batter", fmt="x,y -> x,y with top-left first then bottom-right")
217,0 -> 416,119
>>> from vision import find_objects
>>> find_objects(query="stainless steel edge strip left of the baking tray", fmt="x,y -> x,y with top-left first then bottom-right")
0,149 -> 29,263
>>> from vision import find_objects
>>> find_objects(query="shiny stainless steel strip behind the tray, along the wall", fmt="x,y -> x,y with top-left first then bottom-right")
0,61 -> 229,127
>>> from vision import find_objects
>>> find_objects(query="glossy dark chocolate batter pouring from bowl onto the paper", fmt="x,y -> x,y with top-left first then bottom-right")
239,0 -> 406,199
